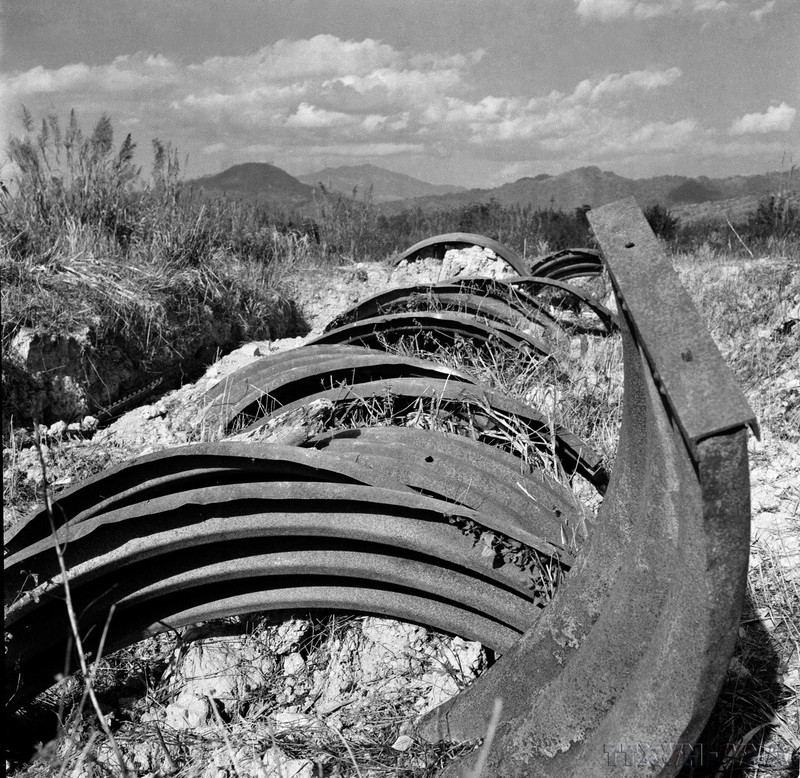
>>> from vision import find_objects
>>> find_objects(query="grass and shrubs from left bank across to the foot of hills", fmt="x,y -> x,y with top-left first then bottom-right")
0,112 -> 800,429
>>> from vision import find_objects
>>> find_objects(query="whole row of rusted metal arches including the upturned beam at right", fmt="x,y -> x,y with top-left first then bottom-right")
6,201 -> 754,776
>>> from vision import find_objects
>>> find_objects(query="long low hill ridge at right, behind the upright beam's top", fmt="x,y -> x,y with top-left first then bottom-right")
386,167 -> 782,211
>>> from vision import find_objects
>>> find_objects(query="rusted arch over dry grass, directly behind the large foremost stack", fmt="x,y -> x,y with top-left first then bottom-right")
231,378 -> 608,491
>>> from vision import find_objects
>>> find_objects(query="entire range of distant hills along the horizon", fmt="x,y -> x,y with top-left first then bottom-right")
189,162 -> 785,212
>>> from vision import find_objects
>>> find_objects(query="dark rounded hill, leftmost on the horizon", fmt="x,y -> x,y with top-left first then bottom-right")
189,162 -> 314,203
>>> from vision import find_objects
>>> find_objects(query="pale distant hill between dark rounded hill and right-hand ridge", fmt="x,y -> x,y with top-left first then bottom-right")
298,165 -> 466,203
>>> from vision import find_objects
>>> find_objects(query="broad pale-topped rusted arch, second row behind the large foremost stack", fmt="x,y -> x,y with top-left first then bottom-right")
203,344 -> 476,431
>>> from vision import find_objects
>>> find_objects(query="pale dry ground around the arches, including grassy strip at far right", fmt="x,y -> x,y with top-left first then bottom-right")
4,246 -> 800,778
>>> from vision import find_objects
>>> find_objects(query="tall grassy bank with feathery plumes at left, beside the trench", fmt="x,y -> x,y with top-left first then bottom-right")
0,111 -> 305,423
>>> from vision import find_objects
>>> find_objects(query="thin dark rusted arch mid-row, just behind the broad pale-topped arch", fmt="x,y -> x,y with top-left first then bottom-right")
309,311 -> 550,357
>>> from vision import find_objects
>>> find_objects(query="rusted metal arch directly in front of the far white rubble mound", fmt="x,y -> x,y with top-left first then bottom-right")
324,276 -> 558,332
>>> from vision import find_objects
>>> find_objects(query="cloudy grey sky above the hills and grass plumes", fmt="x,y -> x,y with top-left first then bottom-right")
0,0 -> 800,186
